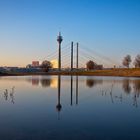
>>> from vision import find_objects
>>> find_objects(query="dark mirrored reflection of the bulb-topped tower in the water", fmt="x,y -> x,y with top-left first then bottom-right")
56,75 -> 62,112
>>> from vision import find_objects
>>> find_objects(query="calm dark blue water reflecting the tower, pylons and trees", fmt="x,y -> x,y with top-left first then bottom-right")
0,76 -> 140,140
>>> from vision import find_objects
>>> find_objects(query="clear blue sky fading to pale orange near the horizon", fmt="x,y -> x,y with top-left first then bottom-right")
0,0 -> 140,66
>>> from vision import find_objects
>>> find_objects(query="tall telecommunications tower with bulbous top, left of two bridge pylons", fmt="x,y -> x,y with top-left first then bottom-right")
57,32 -> 63,71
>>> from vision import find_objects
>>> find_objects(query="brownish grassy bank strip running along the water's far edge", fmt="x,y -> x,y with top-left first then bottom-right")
0,68 -> 140,77
